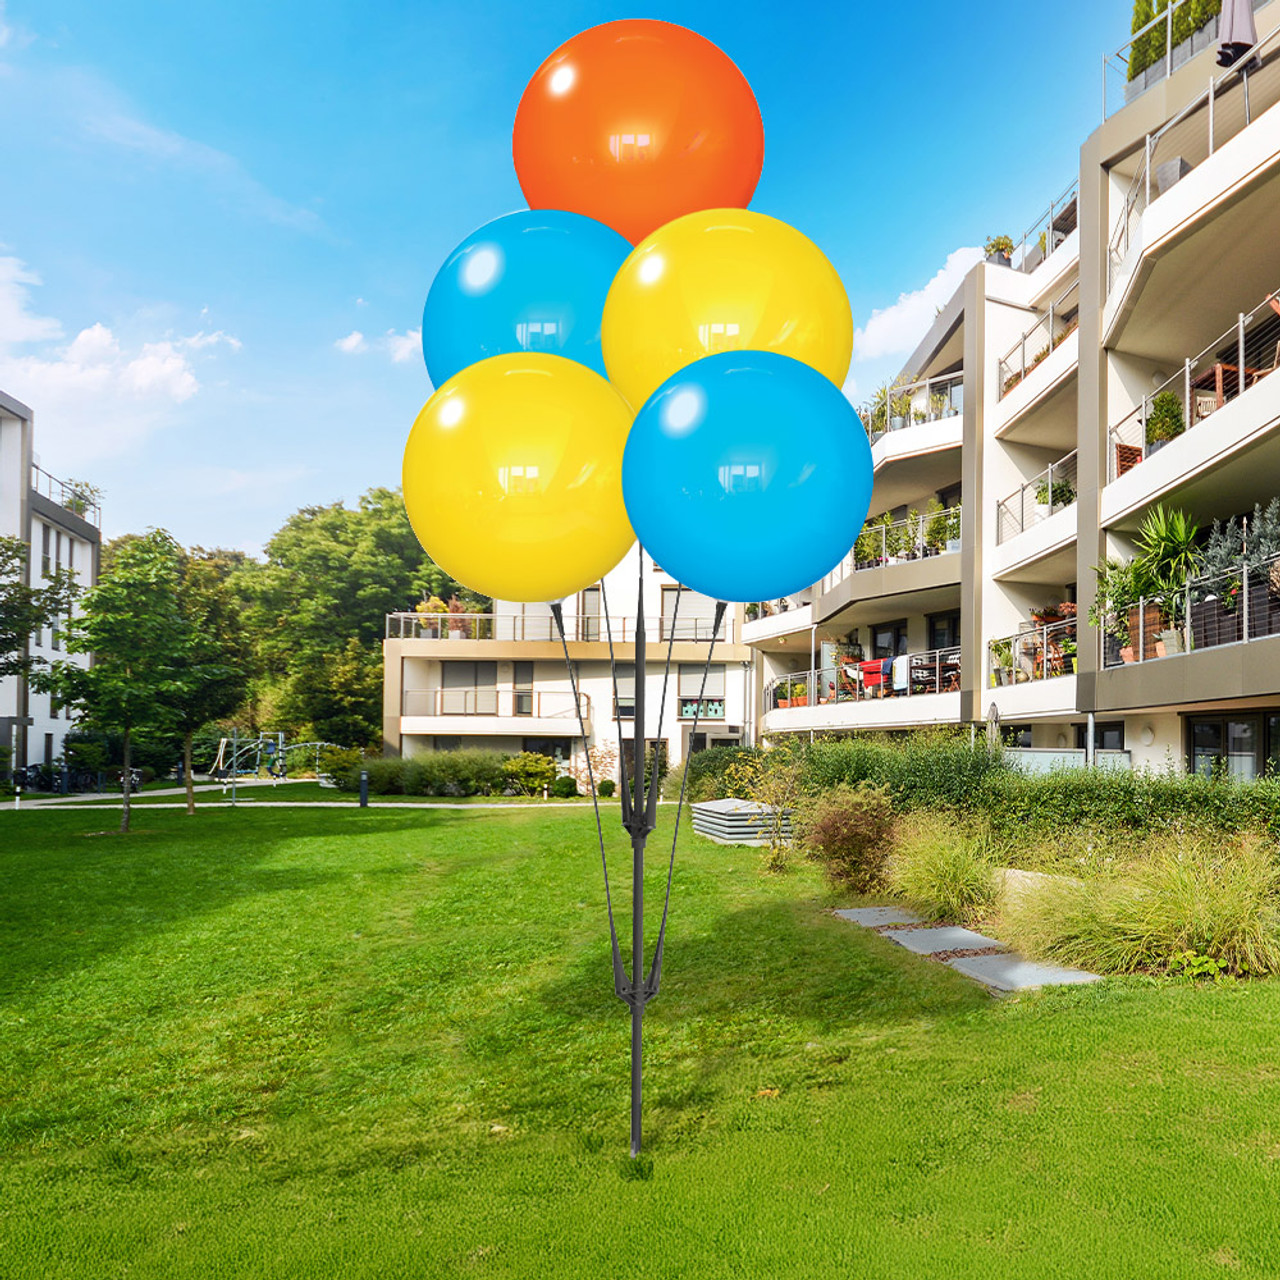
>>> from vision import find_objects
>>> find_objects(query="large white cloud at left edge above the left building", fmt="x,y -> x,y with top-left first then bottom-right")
0,259 -> 241,466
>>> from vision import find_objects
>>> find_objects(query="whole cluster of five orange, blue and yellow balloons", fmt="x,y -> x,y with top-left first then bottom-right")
404,20 -> 872,600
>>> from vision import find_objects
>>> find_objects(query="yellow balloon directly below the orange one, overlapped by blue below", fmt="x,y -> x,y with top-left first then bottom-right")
600,209 -> 854,411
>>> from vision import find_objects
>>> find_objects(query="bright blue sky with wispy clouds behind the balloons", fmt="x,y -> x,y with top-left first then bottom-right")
0,0 -> 1132,550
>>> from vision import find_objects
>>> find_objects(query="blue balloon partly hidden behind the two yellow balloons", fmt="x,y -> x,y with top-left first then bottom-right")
422,209 -> 631,387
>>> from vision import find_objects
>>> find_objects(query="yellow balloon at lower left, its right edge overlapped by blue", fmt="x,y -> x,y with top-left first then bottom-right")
403,352 -> 635,600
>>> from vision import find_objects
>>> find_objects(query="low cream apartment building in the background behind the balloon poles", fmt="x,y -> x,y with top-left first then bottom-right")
383,548 -> 755,778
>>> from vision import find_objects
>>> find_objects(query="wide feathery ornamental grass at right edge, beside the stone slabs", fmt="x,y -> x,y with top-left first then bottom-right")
1006,838 -> 1280,974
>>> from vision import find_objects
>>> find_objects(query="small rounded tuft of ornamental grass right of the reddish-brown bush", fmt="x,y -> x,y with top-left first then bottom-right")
888,820 -> 997,923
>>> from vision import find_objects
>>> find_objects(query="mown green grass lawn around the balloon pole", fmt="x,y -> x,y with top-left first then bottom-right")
0,805 -> 1280,1280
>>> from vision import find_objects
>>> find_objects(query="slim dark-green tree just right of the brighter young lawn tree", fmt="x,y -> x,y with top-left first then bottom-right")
173,547 -> 252,814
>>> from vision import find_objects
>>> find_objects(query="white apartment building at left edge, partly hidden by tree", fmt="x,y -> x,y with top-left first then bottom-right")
0,392 -> 101,767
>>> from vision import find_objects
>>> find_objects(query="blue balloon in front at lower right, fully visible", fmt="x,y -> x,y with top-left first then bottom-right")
622,351 -> 872,602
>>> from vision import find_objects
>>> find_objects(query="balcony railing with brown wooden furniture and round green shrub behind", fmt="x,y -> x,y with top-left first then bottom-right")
1107,291 -> 1280,481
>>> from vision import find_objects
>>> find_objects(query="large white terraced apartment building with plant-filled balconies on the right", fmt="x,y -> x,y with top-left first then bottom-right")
742,0 -> 1280,776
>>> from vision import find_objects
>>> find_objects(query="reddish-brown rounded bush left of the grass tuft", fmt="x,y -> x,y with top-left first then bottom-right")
792,782 -> 893,893
